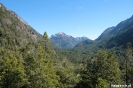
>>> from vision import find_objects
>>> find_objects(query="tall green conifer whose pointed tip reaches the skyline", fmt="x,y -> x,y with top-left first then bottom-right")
24,32 -> 61,88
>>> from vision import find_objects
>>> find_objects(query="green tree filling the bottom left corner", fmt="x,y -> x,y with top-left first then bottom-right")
0,49 -> 27,88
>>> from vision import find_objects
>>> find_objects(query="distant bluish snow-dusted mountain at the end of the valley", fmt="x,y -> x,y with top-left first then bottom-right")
50,32 -> 88,48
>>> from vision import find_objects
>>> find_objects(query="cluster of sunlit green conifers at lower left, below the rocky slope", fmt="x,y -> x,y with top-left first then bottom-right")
0,30 -> 63,88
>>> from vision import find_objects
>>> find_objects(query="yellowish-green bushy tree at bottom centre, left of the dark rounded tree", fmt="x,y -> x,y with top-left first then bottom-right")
56,58 -> 80,88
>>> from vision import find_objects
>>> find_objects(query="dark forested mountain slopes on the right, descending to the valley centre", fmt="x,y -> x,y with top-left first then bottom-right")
75,16 -> 133,50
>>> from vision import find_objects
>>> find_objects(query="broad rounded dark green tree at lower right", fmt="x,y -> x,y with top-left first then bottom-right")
93,51 -> 120,83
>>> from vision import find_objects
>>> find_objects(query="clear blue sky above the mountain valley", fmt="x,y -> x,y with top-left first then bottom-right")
0,0 -> 133,40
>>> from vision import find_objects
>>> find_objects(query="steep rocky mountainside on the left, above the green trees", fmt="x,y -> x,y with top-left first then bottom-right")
0,4 -> 42,48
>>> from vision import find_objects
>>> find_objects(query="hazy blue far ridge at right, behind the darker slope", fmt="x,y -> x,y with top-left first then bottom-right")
96,16 -> 133,41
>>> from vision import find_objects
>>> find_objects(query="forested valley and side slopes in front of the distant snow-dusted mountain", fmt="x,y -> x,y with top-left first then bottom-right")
0,4 -> 133,88
